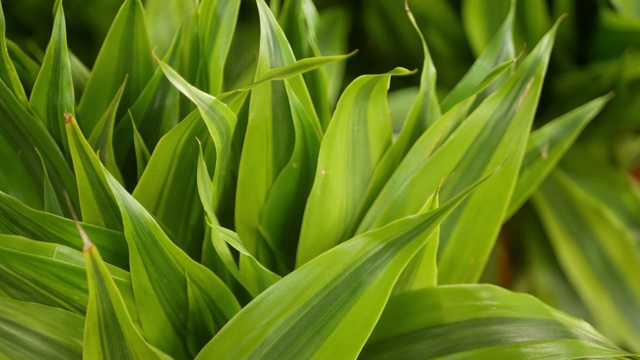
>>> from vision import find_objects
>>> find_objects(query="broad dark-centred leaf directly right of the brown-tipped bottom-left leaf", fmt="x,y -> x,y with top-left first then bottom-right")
103,169 -> 240,358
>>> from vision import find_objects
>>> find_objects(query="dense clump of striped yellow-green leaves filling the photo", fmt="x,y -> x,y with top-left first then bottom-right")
0,0 -> 640,359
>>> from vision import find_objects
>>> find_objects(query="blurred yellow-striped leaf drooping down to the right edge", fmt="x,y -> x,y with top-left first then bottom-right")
533,169 -> 640,351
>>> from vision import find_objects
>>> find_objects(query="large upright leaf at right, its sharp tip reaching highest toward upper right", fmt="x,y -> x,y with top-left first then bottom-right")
359,20 -> 556,283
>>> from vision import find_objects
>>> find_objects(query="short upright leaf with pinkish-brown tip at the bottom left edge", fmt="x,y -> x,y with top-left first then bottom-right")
83,235 -> 170,359
